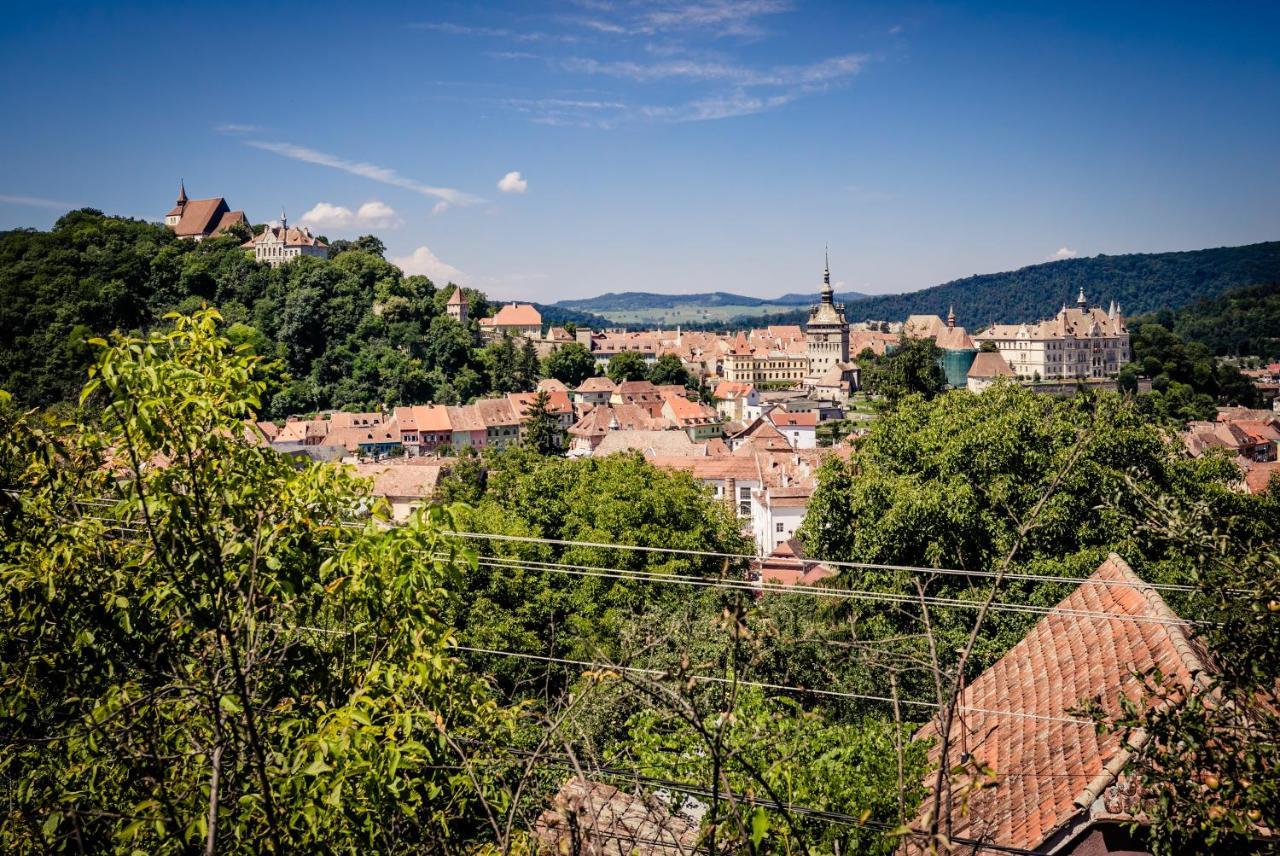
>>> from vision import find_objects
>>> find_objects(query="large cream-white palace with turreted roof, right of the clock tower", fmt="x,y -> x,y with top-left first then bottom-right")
973,288 -> 1129,380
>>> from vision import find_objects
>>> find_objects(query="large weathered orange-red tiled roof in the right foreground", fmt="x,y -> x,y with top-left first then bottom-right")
913,554 -> 1204,852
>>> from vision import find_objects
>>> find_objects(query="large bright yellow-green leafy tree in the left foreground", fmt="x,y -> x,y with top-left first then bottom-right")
0,312 -> 508,853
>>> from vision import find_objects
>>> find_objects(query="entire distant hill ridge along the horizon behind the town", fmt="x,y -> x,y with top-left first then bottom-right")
553,241 -> 1280,330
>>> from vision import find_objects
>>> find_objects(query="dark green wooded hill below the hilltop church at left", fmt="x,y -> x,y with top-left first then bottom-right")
0,209 -> 536,416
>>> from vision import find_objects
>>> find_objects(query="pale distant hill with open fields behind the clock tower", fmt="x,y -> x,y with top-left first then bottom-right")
552,292 -> 864,325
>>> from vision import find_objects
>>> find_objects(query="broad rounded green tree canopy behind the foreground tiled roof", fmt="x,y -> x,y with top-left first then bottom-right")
800,383 -> 1264,672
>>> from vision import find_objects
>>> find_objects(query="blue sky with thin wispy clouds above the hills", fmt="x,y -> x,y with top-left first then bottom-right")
0,0 -> 1280,302
